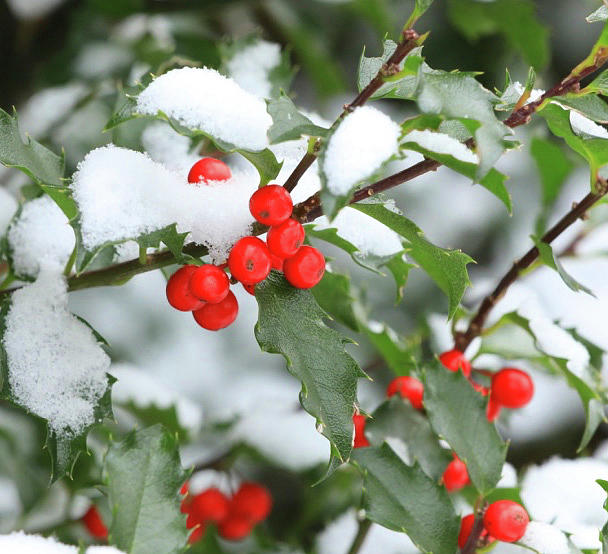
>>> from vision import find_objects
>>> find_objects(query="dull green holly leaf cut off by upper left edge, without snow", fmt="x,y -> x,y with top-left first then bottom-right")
0,109 -> 65,187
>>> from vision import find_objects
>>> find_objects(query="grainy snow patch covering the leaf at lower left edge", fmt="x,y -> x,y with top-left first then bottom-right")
3,271 -> 110,437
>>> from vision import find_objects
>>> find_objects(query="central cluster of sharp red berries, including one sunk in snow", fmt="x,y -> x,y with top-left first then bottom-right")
167,158 -> 325,331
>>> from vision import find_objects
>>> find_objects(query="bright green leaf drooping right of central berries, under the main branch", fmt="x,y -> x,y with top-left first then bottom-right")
353,202 -> 473,319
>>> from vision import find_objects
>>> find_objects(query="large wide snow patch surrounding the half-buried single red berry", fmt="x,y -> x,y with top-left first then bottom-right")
71,146 -> 259,260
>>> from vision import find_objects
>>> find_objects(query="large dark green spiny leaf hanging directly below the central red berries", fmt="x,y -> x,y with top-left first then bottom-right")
255,271 -> 365,462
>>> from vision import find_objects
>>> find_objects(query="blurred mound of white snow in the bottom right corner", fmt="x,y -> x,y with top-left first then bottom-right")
521,452 -> 608,548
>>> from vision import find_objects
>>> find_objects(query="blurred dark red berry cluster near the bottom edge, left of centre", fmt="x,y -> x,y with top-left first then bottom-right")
181,483 -> 272,544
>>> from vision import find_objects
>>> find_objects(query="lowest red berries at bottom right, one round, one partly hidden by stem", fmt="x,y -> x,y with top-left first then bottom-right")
458,500 -> 530,548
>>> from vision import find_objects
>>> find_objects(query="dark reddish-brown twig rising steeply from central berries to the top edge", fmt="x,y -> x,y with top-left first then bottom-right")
283,29 -> 420,196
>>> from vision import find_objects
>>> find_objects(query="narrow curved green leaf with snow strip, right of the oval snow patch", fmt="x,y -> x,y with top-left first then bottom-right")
401,126 -> 513,214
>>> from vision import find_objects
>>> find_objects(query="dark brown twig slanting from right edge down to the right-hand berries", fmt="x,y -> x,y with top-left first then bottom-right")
454,182 -> 608,352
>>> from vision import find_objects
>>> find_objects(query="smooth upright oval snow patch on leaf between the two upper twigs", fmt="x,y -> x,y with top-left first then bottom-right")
323,106 -> 401,195
